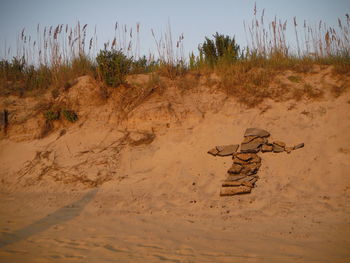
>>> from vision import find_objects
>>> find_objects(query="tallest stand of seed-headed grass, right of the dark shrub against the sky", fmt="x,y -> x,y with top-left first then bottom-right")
244,5 -> 350,58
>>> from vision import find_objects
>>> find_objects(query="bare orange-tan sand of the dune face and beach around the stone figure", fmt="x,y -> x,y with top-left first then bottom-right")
0,71 -> 350,263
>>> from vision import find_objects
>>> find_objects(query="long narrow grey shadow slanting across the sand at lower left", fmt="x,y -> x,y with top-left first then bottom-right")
0,188 -> 98,248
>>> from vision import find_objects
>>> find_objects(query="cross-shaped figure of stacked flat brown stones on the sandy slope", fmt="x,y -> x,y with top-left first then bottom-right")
208,128 -> 304,196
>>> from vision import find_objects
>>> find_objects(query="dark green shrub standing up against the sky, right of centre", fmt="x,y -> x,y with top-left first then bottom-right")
198,32 -> 240,66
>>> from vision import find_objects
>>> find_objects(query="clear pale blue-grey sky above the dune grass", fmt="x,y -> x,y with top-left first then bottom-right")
0,0 -> 350,59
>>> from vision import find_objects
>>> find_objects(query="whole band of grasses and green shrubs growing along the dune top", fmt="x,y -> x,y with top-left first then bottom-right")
0,5 -> 350,106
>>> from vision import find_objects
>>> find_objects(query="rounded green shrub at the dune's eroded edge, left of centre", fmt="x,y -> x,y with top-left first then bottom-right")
96,50 -> 132,87
